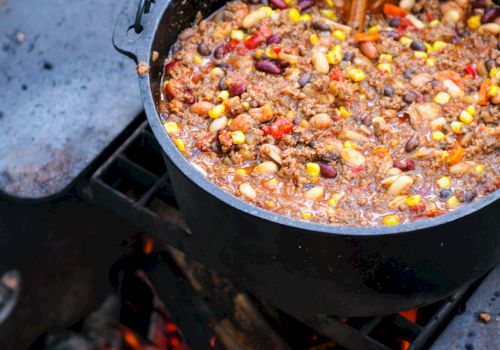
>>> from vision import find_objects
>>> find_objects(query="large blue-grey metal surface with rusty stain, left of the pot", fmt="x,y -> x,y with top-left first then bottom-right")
0,0 -> 142,199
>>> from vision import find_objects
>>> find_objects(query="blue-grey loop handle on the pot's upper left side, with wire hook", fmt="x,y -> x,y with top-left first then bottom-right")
113,0 -> 158,63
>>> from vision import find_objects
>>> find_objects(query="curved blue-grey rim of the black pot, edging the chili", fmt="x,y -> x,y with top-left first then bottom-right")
139,2 -> 500,236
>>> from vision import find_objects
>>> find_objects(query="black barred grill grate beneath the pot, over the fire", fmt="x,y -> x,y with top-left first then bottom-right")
89,117 -> 488,350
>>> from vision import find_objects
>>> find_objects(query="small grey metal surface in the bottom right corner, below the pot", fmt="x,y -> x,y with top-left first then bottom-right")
430,265 -> 500,350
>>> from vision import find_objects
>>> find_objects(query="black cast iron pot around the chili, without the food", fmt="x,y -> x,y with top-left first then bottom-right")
114,0 -> 500,316
